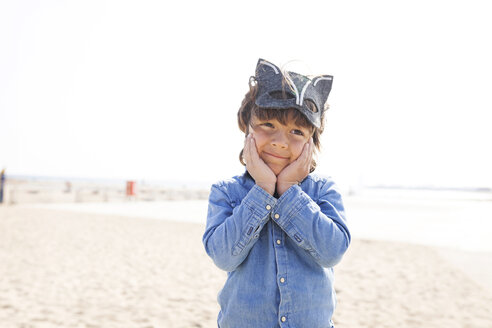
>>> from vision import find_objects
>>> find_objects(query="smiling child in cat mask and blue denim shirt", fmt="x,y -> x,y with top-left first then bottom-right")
203,59 -> 350,328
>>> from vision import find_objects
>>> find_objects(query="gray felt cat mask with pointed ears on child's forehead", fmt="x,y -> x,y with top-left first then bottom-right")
255,58 -> 333,128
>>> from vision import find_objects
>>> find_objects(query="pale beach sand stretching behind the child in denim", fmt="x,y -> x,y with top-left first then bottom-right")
0,206 -> 492,328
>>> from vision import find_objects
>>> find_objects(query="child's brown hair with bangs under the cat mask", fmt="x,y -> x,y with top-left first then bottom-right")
237,77 -> 328,172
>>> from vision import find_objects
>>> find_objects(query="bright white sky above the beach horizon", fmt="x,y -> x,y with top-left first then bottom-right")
0,0 -> 492,188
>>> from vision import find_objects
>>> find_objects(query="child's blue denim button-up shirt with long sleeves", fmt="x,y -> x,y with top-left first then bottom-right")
203,173 -> 350,328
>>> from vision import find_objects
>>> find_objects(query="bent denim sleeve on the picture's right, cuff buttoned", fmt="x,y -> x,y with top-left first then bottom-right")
273,182 -> 350,268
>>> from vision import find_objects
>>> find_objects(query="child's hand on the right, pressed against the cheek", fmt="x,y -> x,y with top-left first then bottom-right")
277,138 -> 314,196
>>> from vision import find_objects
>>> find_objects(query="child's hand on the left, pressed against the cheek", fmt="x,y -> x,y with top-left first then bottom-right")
243,133 -> 277,196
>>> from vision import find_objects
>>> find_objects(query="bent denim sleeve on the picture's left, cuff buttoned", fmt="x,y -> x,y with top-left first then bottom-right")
202,185 -> 277,272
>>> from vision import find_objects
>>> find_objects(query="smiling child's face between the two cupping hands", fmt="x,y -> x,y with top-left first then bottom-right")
250,116 -> 311,175
